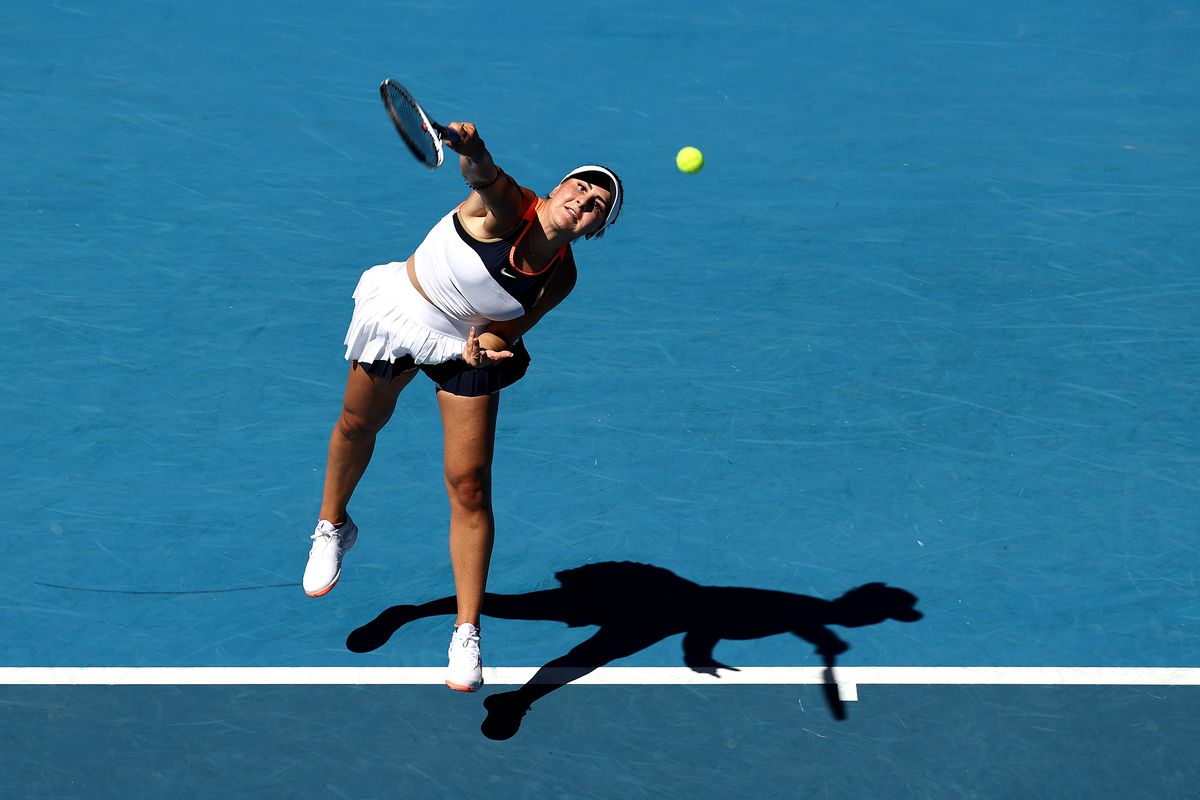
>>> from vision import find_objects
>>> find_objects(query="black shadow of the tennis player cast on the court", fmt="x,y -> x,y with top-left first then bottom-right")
346,561 -> 922,739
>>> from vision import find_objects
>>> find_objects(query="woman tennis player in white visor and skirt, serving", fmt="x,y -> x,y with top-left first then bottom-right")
304,122 -> 622,692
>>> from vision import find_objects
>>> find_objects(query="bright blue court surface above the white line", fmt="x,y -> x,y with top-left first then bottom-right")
0,0 -> 1200,796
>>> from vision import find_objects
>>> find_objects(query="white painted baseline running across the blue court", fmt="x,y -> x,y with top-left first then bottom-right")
0,667 -> 1200,700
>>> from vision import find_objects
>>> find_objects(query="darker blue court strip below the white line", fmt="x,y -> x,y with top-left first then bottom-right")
0,686 -> 1200,800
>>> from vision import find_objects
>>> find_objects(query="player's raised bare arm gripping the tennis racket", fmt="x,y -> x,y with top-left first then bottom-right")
445,122 -> 530,239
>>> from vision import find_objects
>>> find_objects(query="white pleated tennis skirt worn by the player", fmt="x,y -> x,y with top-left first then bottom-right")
346,261 -> 487,363
